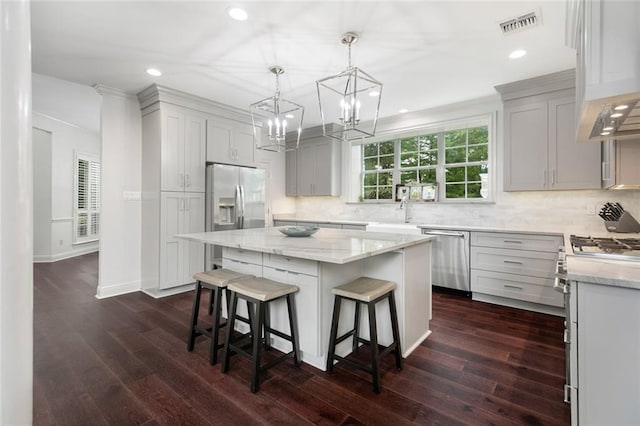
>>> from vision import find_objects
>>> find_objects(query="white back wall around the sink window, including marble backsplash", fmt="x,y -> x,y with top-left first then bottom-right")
295,96 -> 640,234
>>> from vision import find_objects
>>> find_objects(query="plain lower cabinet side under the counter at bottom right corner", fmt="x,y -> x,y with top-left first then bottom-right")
570,282 -> 640,426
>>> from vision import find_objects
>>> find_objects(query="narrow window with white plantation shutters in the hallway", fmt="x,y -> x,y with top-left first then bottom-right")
73,153 -> 100,243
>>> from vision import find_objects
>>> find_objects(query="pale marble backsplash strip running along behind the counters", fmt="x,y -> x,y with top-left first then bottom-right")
295,190 -> 640,234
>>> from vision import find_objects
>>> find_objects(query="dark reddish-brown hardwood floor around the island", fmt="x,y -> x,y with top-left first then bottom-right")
33,254 -> 570,426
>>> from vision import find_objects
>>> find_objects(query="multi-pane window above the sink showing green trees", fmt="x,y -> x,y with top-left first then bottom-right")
356,118 -> 489,201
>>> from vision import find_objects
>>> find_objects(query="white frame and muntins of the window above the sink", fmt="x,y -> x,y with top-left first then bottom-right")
350,113 -> 497,204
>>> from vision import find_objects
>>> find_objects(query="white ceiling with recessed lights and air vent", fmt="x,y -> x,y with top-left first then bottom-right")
31,0 -> 575,127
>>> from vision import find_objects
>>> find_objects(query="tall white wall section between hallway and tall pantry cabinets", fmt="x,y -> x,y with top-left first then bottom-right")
96,86 -> 143,298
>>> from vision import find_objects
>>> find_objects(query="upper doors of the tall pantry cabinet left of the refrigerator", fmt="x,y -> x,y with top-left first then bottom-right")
160,105 -> 206,192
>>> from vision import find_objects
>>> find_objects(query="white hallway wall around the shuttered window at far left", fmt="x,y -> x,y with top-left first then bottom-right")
33,74 -> 101,262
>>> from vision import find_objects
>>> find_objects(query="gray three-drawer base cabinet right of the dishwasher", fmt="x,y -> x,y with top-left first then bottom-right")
470,232 -> 564,314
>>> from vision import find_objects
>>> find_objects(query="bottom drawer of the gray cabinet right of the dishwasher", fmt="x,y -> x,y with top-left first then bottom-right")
471,269 -> 564,307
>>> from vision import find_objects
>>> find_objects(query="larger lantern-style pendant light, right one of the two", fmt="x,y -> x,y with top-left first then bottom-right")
316,32 -> 382,141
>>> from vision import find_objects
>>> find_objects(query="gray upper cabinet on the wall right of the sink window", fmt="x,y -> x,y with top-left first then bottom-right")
496,71 -> 601,191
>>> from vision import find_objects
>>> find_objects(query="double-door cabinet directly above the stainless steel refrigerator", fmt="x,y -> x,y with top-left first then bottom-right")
207,117 -> 255,166
